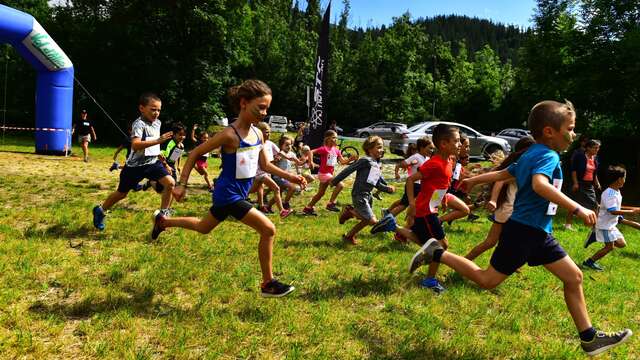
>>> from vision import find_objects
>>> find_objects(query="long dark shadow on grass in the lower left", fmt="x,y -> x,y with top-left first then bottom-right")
29,288 -> 193,320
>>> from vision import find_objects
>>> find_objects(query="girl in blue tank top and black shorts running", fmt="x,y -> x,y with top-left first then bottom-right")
153,80 -> 305,297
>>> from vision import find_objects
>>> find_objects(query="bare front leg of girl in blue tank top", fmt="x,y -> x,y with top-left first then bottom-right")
240,209 -> 276,284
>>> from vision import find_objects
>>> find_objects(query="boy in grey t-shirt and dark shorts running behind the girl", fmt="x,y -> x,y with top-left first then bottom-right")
93,93 -> 175,230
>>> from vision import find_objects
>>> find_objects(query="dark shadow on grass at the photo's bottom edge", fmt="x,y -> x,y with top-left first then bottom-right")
353,328 -> 487,360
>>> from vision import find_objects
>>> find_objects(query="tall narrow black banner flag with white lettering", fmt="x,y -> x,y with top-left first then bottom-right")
304,1 -> 331,149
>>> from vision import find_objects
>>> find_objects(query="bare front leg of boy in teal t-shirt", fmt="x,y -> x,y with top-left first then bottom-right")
544,256 -> 591,332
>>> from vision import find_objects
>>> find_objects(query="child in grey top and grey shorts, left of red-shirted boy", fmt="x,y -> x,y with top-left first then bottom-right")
331,136 -> 395,245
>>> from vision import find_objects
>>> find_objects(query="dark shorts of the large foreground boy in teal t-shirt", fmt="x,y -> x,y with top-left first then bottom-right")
491,219 -> 567,275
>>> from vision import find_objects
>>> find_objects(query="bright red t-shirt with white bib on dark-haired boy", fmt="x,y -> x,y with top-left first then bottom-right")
416,154 -> 453,217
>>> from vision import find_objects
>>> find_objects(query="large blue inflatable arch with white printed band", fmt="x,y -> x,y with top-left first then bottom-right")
0,5 -> 73,155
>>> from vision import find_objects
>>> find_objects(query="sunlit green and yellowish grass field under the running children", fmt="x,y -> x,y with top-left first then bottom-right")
0,138 -> 640,359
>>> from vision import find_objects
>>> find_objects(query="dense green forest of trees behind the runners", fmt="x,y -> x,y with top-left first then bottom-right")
0,0 -> 640,138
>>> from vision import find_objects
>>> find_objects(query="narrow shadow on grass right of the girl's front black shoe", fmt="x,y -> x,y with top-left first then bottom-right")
301,276 -> 401,301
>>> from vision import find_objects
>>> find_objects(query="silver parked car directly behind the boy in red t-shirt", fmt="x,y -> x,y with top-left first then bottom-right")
389,121 -> 511,159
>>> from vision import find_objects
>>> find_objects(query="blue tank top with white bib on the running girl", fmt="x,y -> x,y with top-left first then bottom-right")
212,125 -> 262,206
